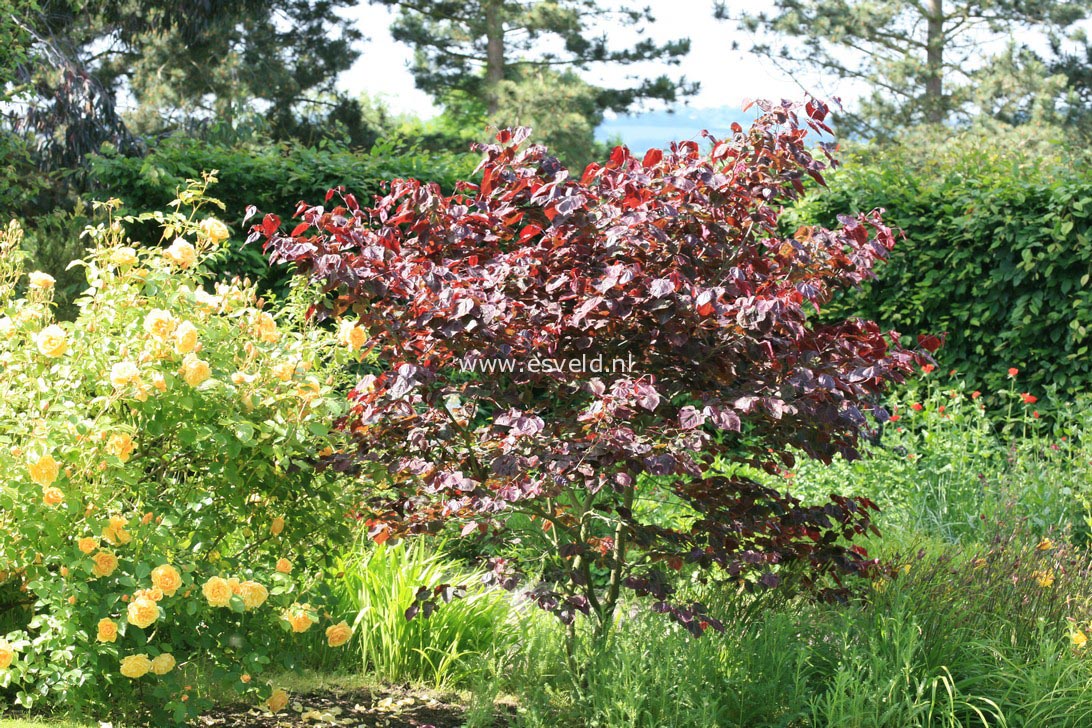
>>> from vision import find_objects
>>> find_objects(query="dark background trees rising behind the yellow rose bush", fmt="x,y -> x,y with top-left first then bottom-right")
9,0 -> 361,167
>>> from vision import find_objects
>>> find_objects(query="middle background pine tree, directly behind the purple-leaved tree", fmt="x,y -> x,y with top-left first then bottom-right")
372,0 -> 697,164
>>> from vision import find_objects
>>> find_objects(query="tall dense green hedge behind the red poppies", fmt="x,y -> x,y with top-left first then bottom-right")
793,129 -> 1092,393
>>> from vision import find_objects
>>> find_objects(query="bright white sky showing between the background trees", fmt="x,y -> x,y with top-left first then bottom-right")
340,0 -> 852,118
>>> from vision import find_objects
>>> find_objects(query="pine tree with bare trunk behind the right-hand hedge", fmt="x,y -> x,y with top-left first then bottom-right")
716,0 -> 1089,134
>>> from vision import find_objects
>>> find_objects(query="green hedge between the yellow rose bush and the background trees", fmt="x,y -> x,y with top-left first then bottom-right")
91,136 -> 477,291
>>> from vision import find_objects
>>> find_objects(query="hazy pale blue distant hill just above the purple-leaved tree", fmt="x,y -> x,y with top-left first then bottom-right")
595,106 -> 756,154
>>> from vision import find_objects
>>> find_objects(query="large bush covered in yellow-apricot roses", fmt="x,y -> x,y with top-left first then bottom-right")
0,180 -> 359,725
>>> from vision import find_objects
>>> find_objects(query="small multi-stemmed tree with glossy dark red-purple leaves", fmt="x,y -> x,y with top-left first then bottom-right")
251,102 -> 926,634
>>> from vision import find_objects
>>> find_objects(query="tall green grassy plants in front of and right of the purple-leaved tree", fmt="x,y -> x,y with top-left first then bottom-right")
470,535 -> 1092,728
